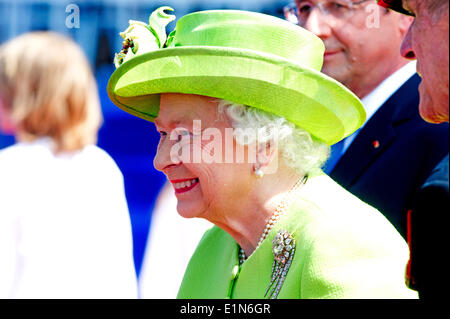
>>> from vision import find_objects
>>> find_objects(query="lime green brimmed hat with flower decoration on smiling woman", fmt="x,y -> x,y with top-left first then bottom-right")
107,7 -> 365,145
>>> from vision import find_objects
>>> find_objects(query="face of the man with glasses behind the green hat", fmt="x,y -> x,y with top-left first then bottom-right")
296,0 -> 411,98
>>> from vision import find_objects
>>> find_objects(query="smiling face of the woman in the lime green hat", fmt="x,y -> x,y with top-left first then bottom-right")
154,93 -> 252,220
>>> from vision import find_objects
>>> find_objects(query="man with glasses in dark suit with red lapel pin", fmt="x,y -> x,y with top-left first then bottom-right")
285,0 -> 449,238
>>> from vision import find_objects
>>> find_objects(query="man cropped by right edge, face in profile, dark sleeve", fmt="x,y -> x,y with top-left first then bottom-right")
378,0 -> 449,298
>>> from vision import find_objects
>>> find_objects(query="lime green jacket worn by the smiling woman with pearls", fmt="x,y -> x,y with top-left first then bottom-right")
178,174 -> 417,299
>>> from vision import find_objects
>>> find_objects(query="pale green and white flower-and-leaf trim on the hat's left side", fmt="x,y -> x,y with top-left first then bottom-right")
114,7 -> 176,68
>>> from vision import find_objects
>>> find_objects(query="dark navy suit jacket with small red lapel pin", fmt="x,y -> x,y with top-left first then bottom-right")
330,75 -> 449,238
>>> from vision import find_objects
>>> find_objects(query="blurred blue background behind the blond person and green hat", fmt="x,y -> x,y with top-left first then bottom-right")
0,0 -> 290,276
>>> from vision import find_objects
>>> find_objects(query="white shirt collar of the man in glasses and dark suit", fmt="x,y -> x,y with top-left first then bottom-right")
342,61 -> 417,154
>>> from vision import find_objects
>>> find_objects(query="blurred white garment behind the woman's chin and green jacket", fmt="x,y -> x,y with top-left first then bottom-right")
139,182 -> 213,299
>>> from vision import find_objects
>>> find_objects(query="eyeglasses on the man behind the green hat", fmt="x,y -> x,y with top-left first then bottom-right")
283,0 -> 369,26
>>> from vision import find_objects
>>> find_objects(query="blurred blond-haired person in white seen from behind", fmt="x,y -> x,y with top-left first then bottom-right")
0,32 -> 137,298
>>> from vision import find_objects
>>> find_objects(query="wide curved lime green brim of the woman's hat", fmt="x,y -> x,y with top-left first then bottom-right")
107,46 -> 365,145
